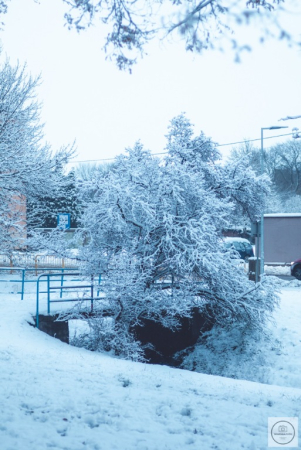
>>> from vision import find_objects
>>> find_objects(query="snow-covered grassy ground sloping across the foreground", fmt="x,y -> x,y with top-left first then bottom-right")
0,281 -> 301,450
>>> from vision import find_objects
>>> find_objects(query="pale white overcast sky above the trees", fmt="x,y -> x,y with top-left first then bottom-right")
0,0 -> 301,167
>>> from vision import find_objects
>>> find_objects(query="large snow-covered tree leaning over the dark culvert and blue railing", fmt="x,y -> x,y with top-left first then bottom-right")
75,114 -> 275,358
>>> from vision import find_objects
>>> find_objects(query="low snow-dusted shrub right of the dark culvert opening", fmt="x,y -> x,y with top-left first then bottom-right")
177,323 -> 282,384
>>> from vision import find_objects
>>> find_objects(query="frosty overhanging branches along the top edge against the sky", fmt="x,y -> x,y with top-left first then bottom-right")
58,0 -> 293,71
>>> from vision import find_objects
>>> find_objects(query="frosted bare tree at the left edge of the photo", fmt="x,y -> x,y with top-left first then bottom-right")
0,61 -> 73,252
